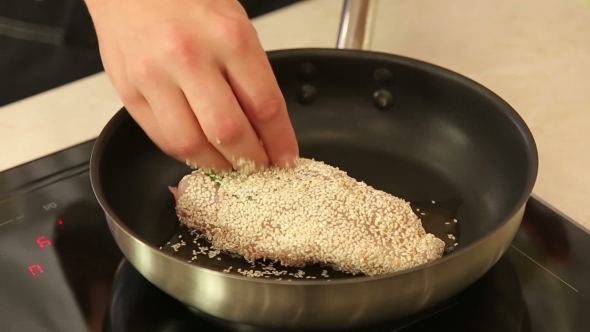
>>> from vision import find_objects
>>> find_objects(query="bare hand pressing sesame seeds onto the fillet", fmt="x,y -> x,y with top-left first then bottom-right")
87,0 -> 299,171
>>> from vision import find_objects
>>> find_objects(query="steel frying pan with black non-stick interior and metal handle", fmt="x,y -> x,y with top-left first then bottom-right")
91,0 -> 538,331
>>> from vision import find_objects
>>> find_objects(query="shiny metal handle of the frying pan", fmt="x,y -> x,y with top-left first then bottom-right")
336,0 -> 377,50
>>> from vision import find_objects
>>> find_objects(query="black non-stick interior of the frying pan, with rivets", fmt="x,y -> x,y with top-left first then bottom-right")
99,50 -> 534,278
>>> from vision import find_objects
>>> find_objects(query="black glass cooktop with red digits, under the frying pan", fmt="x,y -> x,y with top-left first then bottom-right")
0,141 -> 590,332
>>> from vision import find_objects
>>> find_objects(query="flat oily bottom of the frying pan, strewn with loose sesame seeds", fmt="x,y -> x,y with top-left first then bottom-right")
161,144 -> 462,280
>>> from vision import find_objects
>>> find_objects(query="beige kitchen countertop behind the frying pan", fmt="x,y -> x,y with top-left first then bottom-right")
0,0 -> 590,228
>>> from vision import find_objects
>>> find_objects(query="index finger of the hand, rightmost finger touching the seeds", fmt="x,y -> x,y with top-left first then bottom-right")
226,34 -> 299,167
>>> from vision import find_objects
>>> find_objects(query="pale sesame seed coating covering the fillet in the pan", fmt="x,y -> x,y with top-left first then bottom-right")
175,158 -> 445,276
